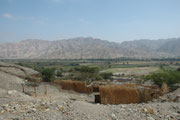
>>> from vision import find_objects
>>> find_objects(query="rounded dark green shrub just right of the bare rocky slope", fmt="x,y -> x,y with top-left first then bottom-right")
42,68 -> 55,82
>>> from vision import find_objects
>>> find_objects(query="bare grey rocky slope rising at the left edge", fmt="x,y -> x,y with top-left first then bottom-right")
0,62 -> 40,91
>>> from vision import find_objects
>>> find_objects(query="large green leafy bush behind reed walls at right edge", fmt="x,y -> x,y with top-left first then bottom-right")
145,69 -> 180,88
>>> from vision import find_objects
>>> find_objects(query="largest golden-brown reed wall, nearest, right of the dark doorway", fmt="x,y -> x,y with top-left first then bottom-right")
99,84 -> 139,104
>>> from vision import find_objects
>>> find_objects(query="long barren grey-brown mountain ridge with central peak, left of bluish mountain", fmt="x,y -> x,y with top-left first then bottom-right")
0,37 -> 137,59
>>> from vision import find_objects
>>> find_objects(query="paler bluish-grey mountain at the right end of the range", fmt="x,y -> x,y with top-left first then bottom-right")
121,38 -> 180,57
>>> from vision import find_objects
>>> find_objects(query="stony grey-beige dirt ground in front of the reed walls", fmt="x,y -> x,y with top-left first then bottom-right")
0,85 -> 180,120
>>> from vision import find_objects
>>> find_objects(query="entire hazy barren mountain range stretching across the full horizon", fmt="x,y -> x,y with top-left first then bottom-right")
0,37 -> 180,59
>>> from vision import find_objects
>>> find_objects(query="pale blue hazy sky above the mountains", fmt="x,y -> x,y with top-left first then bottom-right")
0,0 -> 180,42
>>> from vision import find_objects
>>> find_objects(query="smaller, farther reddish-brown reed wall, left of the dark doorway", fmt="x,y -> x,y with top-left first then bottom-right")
60,80 -> 93,93
